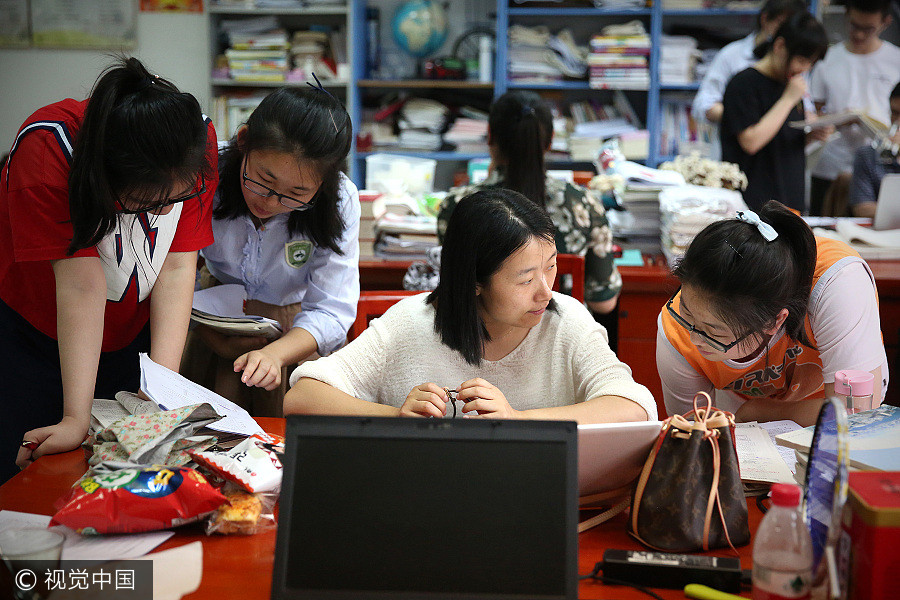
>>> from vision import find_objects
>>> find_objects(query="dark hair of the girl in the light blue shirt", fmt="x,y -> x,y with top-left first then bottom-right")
213,88 -> 353,254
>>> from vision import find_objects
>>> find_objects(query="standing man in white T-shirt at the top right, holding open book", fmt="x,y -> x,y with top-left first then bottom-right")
809,0 -> 900,215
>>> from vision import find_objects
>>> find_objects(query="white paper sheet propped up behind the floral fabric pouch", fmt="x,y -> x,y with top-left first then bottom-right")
140,352 -> 263,435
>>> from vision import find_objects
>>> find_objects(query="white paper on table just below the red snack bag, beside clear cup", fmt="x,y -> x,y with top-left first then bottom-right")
0,510 -> 175,561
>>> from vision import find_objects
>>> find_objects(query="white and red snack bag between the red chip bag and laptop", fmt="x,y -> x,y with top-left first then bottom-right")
188,433 -> 284,493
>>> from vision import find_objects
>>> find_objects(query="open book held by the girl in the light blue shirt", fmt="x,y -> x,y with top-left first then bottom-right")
191,283 -> 281,339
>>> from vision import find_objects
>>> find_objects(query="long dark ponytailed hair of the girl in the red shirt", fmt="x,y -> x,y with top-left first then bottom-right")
67,57 -> 215,254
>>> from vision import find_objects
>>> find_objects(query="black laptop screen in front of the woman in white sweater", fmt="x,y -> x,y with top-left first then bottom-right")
272,415 -> 578,600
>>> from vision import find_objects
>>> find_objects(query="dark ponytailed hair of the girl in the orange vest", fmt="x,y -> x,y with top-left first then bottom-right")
673,200 -> 816,348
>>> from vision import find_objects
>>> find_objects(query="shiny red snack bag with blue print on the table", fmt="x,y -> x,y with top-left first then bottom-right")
51,466 -> 225,534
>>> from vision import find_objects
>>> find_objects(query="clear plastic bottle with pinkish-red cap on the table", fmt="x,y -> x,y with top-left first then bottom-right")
752,483 -> 813,600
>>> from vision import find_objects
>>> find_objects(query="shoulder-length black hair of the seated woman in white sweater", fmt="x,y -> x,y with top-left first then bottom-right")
428,188 -> 556,366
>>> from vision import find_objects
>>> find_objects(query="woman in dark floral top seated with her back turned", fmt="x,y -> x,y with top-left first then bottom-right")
438,91 -> 622,315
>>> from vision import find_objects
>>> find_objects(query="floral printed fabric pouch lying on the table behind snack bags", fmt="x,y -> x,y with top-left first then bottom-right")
89,403 -> 222,466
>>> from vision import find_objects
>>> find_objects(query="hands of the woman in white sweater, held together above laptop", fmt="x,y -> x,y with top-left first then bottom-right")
400,377 -> 519,419
